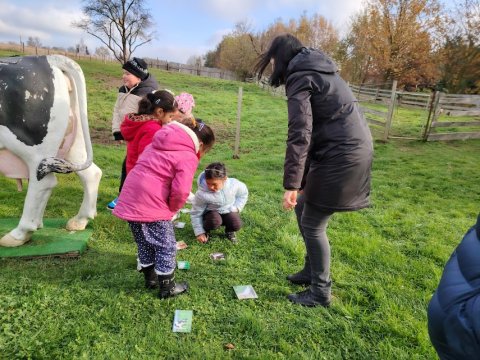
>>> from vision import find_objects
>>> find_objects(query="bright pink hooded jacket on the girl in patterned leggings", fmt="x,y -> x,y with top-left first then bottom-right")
113,122 -> 199,222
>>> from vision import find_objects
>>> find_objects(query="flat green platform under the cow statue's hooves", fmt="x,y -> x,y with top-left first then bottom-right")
0,218 -> 93,259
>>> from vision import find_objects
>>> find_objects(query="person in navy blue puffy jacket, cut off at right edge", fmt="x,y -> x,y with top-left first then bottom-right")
428,214 -> 480,360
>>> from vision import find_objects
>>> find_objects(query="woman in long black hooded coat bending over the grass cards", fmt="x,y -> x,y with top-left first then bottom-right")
256,34 -> 373,306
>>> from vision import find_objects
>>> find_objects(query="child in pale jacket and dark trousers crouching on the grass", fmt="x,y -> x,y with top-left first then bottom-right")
190,162 -> 248,244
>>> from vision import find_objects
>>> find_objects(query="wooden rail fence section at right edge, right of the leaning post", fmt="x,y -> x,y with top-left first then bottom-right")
423,91 -> 480,141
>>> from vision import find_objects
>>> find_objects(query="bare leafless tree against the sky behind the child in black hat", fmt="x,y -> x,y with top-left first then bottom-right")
72,0 -> 154,63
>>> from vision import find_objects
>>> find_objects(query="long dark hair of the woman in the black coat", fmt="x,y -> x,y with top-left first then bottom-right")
254,34 -> 304,87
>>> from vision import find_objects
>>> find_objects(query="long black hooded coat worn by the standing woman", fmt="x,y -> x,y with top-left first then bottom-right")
283,48 -> 373,211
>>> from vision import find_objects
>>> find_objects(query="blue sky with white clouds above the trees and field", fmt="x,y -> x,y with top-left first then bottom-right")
0,0 -> 453,63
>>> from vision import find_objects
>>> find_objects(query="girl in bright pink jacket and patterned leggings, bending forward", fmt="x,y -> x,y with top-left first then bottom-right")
113,121 -> 215,299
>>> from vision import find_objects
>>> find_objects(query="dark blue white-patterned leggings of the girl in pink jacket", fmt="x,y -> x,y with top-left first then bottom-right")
128,221 -> 177,274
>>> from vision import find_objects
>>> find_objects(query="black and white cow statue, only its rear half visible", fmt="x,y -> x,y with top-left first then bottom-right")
0,55 -> 102,247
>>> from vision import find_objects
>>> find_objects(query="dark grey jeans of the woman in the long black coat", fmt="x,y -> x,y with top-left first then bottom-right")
295,194 -> 333,299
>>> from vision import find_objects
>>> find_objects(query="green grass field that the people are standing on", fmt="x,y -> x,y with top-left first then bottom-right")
0,54 -> 480,360
